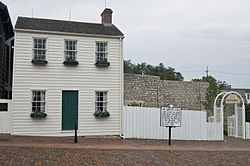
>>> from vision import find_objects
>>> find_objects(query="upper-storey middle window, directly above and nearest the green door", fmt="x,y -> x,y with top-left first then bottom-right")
64,40 -> 77,61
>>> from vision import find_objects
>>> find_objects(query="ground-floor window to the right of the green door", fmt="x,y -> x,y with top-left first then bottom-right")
95,92 -> 108,111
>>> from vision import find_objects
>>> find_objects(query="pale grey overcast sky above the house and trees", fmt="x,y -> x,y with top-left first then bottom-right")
2,0 -> 250,89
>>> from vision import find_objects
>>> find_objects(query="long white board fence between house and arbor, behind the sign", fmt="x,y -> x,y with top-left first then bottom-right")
123,106 -> 224,140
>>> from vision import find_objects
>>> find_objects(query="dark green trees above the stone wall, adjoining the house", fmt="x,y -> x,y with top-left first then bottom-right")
124,60 -> 184,81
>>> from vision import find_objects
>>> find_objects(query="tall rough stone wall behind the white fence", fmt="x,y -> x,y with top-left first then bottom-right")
124,73 -> 209,110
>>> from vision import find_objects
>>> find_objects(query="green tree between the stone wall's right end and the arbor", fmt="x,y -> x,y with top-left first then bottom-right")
192,76 -> 231,110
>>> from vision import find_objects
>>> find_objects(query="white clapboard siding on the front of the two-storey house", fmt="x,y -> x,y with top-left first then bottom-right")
13,31 -> 123,136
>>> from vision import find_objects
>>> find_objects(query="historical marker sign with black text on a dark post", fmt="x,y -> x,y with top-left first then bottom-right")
160,105 -> 182,145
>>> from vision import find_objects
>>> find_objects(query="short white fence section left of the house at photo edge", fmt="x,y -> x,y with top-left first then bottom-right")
0,99 -> 12,134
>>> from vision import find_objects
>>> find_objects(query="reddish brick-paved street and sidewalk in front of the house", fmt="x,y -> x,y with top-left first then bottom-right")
0,137 -> 250,166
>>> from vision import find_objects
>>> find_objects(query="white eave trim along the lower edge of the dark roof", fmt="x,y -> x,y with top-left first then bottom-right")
14,28 -> 125,39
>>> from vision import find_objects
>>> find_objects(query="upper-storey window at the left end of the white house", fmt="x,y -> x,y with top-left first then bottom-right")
33,39 -> 46,60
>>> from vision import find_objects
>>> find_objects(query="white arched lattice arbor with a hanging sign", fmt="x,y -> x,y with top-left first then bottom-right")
210,91 -> 246,139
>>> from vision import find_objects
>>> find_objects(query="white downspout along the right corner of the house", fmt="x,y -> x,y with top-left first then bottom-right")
120,38 -> 125,139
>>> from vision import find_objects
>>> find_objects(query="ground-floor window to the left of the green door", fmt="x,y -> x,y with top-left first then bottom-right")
32,91 -> 46,112
